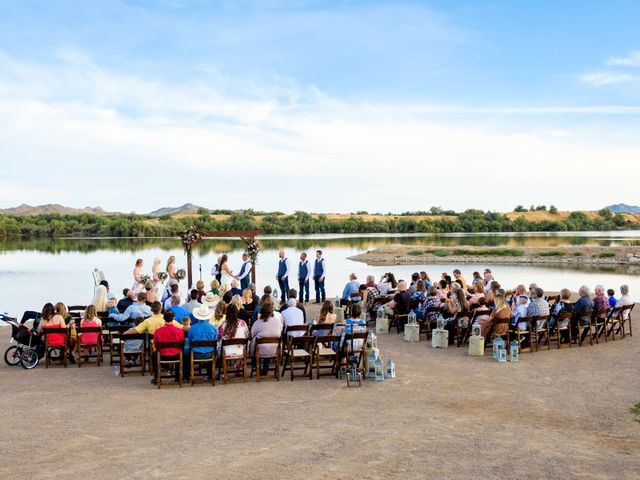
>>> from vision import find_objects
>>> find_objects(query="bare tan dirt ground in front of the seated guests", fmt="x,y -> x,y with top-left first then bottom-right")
0,306 -> 640,479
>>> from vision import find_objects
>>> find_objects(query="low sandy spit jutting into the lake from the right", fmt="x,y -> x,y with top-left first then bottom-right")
349,245 -> 640,267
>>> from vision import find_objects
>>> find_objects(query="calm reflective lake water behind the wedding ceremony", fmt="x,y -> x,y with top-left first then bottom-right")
0,231 -> 640,314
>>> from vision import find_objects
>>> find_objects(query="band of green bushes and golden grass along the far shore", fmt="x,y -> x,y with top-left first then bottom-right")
0,207 -> 640,238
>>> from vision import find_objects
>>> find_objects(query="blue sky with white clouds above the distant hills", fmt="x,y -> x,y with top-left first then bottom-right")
0,0 -> 640,213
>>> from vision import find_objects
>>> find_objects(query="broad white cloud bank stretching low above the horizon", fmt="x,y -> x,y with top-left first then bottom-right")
0,50 -> 640,212
